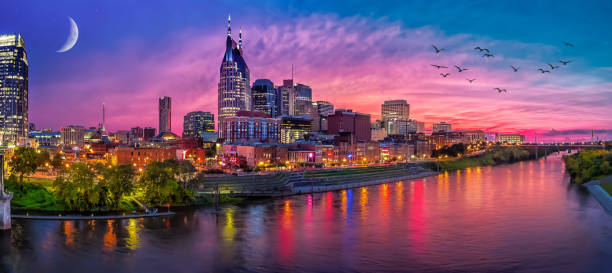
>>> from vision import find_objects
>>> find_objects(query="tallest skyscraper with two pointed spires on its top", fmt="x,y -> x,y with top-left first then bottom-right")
217,16 -> 251,135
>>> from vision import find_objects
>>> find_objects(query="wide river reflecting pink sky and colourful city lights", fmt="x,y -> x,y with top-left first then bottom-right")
0,155 -> 612,273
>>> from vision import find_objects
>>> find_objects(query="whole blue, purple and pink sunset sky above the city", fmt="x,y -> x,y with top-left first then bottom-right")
0,0 -> 612,141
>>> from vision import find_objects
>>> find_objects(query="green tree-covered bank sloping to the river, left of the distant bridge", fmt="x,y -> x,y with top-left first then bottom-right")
423,146 -> 556,171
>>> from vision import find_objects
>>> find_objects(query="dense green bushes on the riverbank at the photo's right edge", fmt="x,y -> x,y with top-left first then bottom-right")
564,150 -> 612,184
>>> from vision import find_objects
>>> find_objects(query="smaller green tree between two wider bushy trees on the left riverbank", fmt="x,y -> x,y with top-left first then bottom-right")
100,165 -> 136,208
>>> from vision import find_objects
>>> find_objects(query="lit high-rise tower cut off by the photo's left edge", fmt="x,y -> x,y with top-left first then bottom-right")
0,34 -> 28,144
